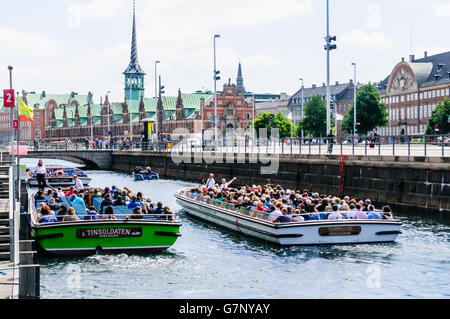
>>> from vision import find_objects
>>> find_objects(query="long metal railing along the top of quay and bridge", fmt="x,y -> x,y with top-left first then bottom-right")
9,134 -> 450,157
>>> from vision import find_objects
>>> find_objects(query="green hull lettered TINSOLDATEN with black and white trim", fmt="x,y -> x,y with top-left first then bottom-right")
32,220 -> 181,256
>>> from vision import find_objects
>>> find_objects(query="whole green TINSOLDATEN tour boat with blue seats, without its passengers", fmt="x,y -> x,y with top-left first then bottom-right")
29,192 -> 181,256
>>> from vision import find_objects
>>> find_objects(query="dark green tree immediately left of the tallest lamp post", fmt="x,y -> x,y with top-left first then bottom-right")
297,95 -> 333,137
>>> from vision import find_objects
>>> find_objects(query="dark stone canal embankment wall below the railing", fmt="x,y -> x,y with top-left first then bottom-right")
111,152 -> 450,214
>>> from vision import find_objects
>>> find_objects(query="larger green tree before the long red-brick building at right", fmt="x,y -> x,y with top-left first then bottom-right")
342,84 -> 389,135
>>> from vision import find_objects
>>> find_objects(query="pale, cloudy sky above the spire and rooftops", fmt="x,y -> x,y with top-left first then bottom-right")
0,0 -> 450,101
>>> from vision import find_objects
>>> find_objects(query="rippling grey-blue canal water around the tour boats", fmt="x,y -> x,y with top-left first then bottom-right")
22,161 -> 450,299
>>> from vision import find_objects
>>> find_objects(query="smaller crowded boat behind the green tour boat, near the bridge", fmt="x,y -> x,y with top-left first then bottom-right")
28,167 -> 92,187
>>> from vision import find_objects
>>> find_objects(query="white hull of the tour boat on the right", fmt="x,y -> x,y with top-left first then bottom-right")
175,193 -> 402,246
